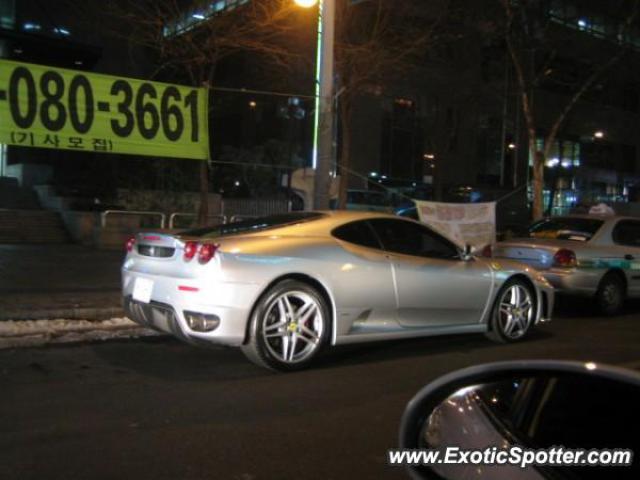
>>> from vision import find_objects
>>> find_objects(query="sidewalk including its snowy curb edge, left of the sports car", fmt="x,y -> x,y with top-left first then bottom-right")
0,244 -> 159,349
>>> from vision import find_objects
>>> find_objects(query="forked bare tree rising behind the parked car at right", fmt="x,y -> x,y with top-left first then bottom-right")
500,0 -> 639,219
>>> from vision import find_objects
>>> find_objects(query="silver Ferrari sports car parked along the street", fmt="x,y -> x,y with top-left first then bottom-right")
122,211 -> 553,370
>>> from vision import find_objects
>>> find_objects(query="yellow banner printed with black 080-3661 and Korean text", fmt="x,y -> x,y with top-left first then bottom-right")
0,60 -> 209,160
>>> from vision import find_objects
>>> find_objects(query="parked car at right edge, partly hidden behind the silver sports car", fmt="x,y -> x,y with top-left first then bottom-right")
493,215 -> 640,315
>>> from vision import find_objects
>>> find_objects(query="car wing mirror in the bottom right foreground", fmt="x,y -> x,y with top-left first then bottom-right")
398,360 -> 640,480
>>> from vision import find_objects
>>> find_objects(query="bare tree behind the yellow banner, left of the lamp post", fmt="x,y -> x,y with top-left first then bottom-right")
92,0 -> 308,224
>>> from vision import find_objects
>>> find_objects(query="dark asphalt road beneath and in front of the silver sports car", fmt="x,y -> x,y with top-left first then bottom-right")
0,306 -> 640,480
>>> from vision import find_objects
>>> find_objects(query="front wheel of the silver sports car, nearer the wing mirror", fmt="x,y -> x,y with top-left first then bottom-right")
487,278 -> 536,343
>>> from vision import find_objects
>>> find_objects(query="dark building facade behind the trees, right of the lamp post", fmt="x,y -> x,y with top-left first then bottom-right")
344,0 -> 640,213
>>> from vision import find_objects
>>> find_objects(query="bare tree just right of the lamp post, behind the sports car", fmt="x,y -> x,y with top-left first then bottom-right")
335,0 -> 447,208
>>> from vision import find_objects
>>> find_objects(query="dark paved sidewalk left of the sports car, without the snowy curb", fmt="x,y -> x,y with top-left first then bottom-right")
0,244 -> 124,321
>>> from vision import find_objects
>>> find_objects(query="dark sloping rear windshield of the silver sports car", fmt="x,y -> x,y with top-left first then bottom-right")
180,212 -> 325,237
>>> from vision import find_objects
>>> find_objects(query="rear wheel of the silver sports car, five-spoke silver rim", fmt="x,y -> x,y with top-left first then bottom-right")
242,280 -> 330,371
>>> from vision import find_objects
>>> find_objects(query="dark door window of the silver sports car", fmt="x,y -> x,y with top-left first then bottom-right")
370,219 -> 459,259
